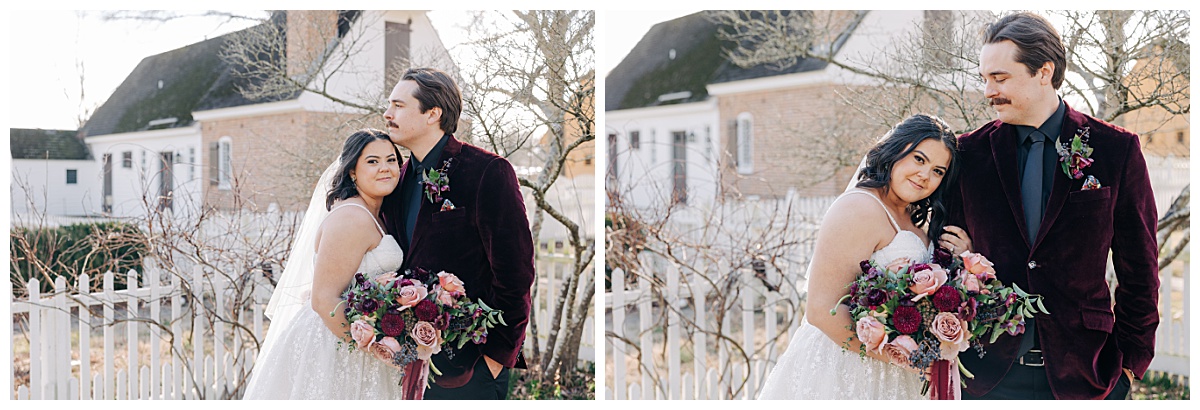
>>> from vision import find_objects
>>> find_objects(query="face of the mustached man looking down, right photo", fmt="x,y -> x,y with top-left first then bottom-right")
979,40 -> 1057,127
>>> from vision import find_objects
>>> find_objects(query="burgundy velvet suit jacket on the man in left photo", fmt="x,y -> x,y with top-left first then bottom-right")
383,135 -> 534,388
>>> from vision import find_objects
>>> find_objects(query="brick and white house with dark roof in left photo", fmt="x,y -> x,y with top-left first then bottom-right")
80,11 -> 455,217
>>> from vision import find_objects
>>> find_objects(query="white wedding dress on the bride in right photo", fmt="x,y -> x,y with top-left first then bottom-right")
758,189 -> 932,399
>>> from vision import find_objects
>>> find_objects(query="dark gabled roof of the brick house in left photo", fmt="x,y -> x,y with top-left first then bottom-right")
80,11 -> 358,137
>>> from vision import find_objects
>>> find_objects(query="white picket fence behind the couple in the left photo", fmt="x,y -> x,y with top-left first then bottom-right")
10,254 -> 595,400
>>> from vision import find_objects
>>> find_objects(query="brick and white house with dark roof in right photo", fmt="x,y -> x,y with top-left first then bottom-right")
605,11 -> 955,207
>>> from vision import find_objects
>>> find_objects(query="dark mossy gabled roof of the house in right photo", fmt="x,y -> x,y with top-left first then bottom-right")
605,12 -> 852,111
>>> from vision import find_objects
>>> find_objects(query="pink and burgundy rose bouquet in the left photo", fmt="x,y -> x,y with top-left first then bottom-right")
330,269 -> 508,399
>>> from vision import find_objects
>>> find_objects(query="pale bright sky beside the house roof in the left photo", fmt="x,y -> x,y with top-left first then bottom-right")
6,11 -> 482,129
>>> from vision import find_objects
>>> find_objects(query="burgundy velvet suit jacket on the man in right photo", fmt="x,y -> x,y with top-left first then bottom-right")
947,107 -> 1158,399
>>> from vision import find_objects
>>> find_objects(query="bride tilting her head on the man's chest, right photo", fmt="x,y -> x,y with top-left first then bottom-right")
758,114 -> 970,399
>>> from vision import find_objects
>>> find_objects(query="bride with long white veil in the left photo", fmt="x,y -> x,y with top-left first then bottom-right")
244,129 -> 403,399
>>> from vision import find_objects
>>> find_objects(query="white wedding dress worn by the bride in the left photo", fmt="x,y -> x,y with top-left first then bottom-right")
244,204 -> 404,400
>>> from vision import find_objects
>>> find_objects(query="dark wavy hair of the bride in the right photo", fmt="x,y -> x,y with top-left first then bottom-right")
854,114 -> 959,241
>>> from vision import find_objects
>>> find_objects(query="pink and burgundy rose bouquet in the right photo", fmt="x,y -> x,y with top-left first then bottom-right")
829,249 -> 1050,399
